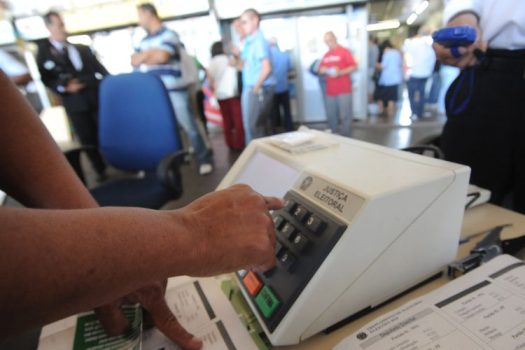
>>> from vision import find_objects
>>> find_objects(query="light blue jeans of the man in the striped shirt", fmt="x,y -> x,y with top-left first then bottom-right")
169,90 -> 211,164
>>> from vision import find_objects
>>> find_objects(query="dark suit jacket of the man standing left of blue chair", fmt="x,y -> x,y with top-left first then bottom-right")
37,40 -> 109,112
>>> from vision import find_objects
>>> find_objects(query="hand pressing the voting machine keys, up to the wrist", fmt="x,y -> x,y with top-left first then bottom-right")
180,185 -> 284,276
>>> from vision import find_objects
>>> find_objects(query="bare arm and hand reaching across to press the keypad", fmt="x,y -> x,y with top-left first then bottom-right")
0,186 -> 281,336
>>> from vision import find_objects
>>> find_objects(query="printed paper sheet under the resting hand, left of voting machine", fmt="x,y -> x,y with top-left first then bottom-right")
38,277 -> 257,350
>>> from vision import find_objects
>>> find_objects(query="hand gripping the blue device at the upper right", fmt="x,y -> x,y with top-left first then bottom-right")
432,13 -> 487,69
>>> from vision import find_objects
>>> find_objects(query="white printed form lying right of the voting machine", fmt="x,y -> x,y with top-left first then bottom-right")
334,255 -> 525,350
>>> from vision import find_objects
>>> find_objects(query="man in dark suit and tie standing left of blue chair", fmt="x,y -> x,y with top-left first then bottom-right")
36,11 -> 109,181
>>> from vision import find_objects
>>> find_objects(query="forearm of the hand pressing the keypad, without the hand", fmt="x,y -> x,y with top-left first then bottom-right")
0,208 -> 192,338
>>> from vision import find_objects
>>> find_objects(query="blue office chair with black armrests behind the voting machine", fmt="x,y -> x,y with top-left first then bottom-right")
66,73 -> 184,209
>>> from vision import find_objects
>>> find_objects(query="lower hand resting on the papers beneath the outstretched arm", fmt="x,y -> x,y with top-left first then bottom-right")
95,280 -> 202,350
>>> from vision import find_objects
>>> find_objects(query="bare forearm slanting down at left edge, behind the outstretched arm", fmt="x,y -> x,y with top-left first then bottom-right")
0,73 -> 97,208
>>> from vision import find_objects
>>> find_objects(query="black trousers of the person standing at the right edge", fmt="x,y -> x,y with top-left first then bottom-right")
441,51 -> 525,213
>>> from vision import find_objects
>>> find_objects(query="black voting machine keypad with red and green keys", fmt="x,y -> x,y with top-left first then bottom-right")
237,191 -> 346,332
